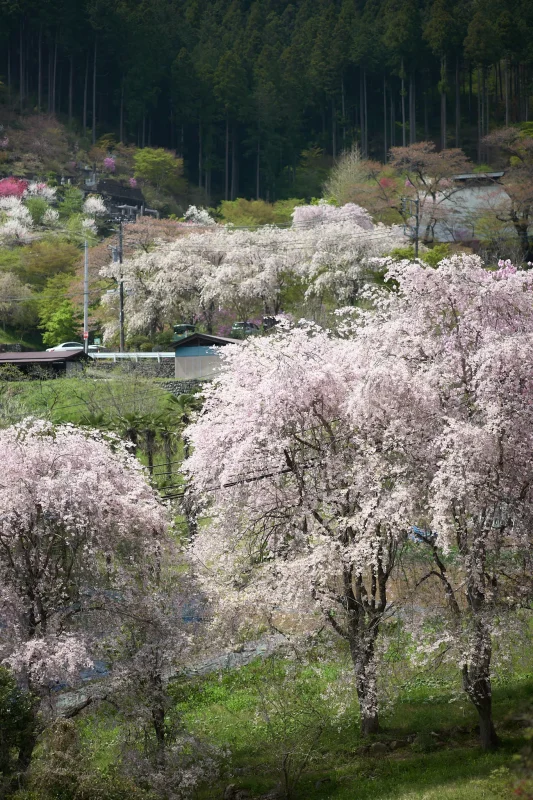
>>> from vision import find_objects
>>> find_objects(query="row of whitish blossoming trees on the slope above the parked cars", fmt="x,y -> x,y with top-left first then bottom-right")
103,204 -> 405,332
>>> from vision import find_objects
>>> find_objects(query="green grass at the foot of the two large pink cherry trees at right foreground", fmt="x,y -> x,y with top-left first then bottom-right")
172,648 -> 533,800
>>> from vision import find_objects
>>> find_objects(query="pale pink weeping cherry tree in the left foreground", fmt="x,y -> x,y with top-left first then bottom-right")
0,420 -> 168,771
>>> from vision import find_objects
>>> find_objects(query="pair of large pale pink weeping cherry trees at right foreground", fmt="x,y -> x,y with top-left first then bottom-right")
188,256 -> 533,748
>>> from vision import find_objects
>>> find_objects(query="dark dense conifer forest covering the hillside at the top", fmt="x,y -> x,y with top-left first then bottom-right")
0,0 -> 533,200
